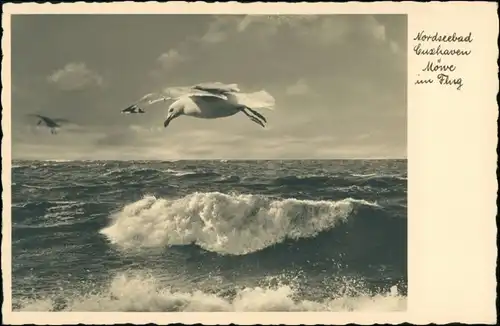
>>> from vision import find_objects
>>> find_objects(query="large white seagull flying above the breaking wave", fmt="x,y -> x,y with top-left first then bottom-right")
124,82 -> 275,128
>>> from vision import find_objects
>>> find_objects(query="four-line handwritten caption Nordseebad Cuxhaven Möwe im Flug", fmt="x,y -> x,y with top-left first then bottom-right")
413,31 -> 473,90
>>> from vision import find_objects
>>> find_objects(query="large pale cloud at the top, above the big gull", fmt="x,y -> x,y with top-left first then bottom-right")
150,15 -> 400,84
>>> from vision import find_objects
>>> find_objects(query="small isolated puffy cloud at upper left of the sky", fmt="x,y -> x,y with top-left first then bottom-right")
47,62 -> 103,91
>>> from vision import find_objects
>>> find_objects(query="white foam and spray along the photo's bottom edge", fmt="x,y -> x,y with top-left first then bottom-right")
15,273 -> 406,312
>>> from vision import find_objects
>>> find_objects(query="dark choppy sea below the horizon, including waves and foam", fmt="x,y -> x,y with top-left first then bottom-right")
12,160 -> 407,311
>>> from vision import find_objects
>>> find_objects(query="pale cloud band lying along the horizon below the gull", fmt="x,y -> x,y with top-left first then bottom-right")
14,119 -> 405,159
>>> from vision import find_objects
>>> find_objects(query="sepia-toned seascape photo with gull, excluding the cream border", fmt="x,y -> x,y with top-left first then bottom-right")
8,13 -> 411,312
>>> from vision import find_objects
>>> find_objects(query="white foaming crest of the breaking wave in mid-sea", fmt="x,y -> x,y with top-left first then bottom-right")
101,192 -> 377,255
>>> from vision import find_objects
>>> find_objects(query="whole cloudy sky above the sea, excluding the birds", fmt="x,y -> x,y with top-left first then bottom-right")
12,15 -> 407,160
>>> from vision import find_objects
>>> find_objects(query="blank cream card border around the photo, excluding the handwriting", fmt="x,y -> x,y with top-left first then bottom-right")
2,1 -> 498,324
